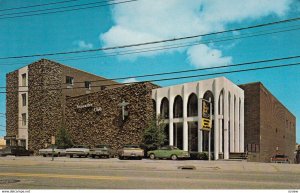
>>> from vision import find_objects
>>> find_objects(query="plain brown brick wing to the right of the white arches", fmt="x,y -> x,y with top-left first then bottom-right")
240,82 -> 296,162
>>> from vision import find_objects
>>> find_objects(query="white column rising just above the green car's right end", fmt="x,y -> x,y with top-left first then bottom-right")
183,85 -> 189,151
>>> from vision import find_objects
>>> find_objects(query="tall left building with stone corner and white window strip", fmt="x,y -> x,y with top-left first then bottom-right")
5,59 -> 120,150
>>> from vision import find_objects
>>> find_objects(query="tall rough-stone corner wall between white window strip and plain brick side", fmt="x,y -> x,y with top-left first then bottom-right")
28,60 -> 62,150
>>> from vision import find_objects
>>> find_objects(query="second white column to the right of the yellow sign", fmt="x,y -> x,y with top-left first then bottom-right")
223,90 -> 229,159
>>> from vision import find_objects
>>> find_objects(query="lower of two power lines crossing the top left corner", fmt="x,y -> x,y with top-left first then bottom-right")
0,0 -> 138,20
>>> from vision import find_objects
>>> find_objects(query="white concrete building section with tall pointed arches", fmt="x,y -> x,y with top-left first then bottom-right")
152,77 -> 244,160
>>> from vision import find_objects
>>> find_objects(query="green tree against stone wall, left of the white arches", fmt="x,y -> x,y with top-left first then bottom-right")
143,116 -> 166,150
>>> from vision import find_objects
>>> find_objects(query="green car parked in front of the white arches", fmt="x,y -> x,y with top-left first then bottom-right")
147,146 -> 190,160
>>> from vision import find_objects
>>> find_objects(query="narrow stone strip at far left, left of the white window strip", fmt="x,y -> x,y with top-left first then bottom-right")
6,71 -> 20,136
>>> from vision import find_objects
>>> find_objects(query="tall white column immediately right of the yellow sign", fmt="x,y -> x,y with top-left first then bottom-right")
213,81 -> 219,160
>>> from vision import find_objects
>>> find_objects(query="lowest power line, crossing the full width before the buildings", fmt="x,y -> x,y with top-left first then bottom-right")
0,62 -> 300,94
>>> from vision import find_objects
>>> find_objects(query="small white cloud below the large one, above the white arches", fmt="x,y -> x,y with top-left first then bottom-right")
187,44 -> 232,68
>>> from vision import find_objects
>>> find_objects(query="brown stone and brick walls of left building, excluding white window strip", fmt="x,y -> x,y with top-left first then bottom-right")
6,59 -> 120,152
